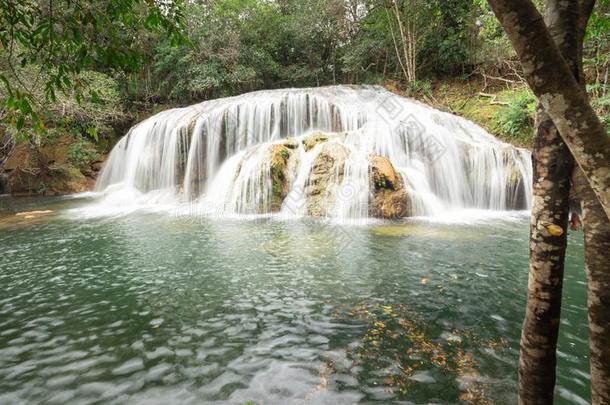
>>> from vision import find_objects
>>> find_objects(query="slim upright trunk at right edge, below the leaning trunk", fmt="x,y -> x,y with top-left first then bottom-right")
574,172 -> 610,405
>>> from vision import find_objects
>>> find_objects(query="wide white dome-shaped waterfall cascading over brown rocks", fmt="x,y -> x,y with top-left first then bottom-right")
96,86 -> 532,219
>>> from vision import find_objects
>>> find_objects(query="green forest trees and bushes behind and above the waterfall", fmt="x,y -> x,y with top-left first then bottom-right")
0,0 -> 610,193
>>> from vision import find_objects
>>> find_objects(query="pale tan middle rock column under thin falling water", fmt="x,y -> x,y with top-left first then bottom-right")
305,142 -> 349,217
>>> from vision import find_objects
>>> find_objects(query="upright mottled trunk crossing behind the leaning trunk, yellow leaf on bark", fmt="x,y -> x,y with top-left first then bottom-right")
518,0 -> 579,404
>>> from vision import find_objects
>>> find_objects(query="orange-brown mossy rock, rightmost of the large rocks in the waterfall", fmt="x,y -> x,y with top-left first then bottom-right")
369,156 -> 409,219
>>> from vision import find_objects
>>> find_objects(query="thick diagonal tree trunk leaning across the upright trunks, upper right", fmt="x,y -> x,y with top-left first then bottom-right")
488,0 -> 610,218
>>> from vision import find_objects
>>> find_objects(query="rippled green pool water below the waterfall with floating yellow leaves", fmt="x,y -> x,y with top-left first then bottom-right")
0,198 -> 589,404
